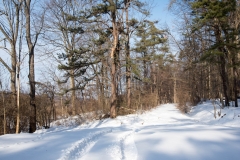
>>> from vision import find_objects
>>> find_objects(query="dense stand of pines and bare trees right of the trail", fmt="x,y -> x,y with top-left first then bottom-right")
170,0 -> 240,107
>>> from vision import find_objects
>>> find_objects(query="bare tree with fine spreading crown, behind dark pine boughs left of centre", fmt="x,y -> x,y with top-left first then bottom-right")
45,0 -> 92,115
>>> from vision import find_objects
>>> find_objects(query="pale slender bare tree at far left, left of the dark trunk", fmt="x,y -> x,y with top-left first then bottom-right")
0,0 -> 22,133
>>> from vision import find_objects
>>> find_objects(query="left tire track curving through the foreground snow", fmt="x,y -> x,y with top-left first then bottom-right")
58,130 -> 112,160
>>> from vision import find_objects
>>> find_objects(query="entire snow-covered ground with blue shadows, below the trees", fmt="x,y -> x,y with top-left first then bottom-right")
0,101 -> 240,160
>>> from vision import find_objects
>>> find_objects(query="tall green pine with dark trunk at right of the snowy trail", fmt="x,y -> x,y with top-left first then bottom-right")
189,0 -> 237,106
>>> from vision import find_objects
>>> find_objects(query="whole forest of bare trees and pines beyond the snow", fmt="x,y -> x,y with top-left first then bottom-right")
0,0 -> 240,135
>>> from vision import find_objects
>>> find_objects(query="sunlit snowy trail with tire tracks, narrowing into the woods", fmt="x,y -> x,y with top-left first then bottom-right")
56,105 -> 240,160
